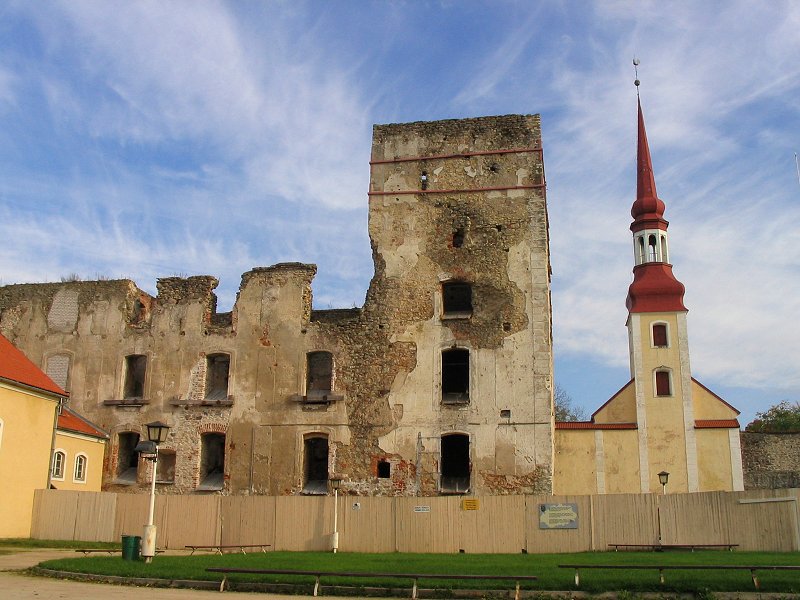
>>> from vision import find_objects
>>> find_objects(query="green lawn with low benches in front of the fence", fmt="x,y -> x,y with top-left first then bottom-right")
36,551 -> 800,594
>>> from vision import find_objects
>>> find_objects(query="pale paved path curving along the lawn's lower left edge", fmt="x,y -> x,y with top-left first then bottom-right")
0,550 -> 374,600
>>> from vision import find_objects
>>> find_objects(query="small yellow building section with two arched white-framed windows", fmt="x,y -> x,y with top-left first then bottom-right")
50,407 -> 108,492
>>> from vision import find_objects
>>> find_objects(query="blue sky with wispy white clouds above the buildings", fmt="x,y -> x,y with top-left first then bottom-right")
0,0 -> 800,424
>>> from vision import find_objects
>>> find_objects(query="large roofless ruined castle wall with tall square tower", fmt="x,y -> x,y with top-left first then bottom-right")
0,115 -> 553,495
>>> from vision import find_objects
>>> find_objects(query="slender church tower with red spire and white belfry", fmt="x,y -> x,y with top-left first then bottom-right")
626,101 -> 699,492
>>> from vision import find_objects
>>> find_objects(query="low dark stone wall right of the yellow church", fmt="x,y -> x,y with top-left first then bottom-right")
740,431 -> 800,490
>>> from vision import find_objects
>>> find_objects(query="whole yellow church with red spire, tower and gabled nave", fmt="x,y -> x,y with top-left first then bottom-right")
553,97 -> 744,494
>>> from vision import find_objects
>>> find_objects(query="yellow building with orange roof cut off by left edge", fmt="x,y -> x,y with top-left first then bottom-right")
0,335 -> 67,537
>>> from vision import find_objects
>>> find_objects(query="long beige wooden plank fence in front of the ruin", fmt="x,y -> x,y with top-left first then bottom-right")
31,489 -> 800,553
